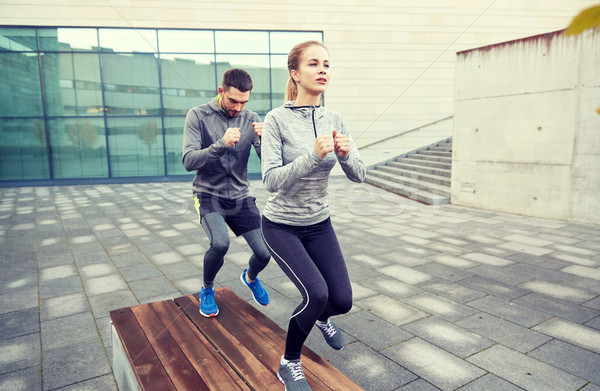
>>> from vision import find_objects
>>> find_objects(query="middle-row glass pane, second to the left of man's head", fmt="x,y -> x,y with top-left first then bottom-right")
102,53 -> 161,115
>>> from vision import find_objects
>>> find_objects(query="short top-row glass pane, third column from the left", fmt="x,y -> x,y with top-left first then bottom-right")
99,29 -> 157,52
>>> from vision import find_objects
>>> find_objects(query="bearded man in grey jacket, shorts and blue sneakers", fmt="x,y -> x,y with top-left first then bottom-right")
183,69 -> 271,317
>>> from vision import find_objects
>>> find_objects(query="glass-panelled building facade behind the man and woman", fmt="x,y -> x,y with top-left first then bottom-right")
0,27 -> 323,186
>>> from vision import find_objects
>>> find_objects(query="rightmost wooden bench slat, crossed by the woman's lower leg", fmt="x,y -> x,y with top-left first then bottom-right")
217,288 -> 363,391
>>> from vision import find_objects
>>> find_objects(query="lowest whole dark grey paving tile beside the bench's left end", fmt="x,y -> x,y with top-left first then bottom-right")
43,338 -> 111,390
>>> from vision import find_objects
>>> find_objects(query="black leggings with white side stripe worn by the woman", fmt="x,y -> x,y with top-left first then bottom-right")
262,217 -> 352,360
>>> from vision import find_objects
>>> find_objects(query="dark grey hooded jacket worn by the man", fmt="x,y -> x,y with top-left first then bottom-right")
182,97 -> 261,200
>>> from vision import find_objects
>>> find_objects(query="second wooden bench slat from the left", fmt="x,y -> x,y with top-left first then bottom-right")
131,304 -> 209,391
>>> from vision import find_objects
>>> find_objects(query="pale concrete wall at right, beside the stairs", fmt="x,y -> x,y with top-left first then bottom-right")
451,31 -> 600,223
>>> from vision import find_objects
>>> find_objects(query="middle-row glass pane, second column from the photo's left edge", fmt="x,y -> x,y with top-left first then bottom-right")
42,53 -> 104,116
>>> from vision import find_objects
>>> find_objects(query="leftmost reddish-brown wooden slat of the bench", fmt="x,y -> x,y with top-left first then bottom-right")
110,308 -> 176,391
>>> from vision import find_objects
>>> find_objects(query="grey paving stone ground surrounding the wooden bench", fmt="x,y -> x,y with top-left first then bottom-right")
0,178 -> 600,391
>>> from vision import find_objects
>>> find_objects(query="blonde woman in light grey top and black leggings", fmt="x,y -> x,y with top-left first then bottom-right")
261,41 -> 366,391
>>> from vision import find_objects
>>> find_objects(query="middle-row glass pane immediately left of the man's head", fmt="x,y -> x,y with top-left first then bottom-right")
161,54 -> 217,115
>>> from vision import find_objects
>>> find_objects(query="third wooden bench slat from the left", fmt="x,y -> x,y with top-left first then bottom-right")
150,300 -> 249,390
